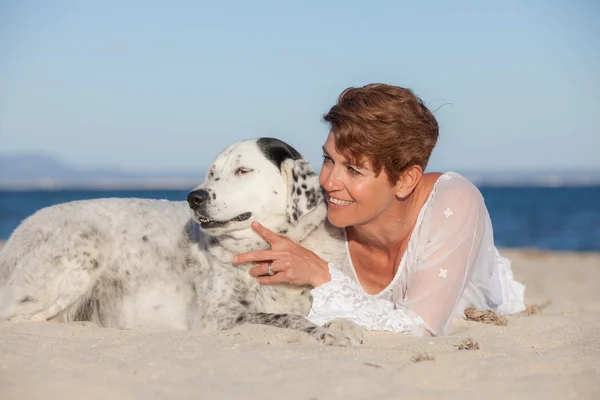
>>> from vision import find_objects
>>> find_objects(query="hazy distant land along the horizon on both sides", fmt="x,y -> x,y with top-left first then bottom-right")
0,154 -> 600,189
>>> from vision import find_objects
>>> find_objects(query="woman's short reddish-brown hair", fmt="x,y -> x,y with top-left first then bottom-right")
323,84 -> 439,184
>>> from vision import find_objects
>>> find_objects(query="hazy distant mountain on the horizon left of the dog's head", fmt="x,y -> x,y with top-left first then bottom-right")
0,154 -> 204,189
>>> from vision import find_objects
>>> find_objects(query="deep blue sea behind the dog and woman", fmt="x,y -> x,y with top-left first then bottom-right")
0,186 -> 600,251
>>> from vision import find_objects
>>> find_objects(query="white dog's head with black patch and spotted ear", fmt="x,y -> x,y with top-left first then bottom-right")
187,138 -> 324,236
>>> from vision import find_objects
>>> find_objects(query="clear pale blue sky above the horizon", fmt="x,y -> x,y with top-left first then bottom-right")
0,0 -> 600,171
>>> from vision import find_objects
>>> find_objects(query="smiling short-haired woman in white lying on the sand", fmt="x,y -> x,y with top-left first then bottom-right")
234,84 -> 525,336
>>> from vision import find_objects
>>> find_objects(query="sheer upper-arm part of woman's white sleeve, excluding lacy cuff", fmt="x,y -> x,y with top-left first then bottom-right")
403,175 -> 493,335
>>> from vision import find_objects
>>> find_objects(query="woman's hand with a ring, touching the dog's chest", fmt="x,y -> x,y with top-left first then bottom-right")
233,222 -> 331,287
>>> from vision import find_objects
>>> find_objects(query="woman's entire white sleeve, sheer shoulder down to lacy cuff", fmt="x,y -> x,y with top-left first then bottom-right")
309,175 -> 502,335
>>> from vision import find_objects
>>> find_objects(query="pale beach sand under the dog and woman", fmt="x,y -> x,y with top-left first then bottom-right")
0,250 -> 600,400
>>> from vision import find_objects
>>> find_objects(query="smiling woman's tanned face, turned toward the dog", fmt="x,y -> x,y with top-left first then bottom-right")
319,133 -> 396,228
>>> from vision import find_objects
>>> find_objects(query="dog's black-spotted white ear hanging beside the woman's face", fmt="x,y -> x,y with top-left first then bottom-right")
281,158 -> 323,225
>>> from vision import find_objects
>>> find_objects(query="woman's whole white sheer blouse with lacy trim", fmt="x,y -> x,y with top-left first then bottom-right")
308,172 -> 525,336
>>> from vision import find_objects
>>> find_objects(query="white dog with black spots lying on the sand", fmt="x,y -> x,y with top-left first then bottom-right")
0,138 -> 362,346
